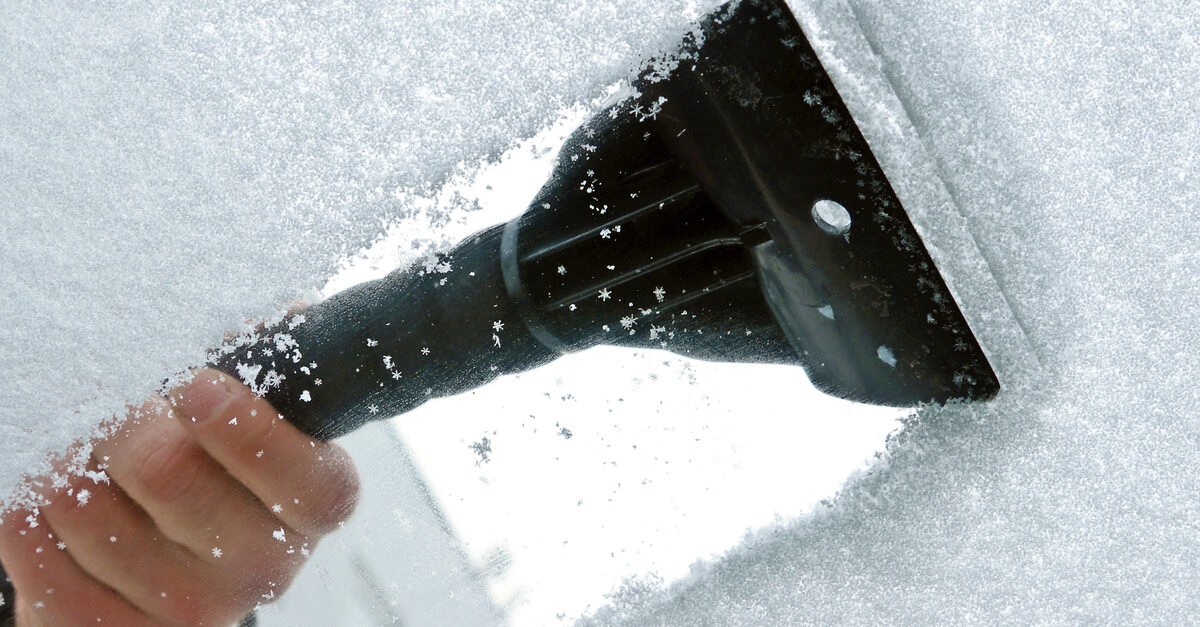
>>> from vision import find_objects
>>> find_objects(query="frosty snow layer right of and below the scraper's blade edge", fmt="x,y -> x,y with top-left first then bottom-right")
594,0 -> 1200,625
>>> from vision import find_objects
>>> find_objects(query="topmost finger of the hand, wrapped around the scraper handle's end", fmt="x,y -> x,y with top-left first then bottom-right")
170,370 -> 359,535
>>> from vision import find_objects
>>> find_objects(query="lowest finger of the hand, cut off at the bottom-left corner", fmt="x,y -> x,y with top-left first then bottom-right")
0,510 -> 157,626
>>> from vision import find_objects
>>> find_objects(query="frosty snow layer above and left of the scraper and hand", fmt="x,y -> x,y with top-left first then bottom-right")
0,0 -> 713,492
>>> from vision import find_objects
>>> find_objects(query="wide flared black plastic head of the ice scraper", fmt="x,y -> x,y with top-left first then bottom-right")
501,0 -> 998,406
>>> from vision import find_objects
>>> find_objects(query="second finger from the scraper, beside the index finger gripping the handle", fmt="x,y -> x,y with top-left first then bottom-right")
92,399 -> 305,577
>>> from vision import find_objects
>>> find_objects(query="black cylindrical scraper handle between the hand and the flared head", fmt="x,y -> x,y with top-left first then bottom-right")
214,227 -> 557,440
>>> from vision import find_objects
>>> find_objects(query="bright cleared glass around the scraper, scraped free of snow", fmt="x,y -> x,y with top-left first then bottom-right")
260,124 -> 905,625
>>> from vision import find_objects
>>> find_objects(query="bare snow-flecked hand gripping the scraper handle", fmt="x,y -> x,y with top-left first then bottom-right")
0,370 -> 358,626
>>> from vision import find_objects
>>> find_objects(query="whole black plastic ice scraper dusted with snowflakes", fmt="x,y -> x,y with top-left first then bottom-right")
215,0 -> 1000,438
